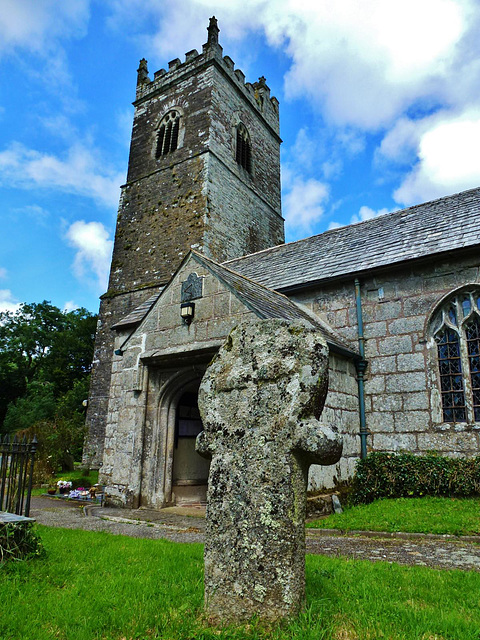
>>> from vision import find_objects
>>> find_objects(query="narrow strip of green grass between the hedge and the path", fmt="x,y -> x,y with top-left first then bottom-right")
307,497 -> 480,535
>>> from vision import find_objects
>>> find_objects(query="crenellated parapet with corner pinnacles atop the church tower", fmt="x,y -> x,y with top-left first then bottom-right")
134,16 -> 279,134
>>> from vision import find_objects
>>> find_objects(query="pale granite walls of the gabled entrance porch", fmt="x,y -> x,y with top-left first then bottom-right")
100,256 -> 359,507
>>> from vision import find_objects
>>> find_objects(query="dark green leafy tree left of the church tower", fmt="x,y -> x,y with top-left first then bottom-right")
0,300 -> 96,432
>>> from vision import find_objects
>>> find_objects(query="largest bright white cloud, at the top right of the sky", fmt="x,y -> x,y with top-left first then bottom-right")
280,0 -> 478,130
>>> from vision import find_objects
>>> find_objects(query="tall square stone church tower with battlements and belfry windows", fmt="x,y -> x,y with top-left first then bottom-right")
84,18 -> 284,467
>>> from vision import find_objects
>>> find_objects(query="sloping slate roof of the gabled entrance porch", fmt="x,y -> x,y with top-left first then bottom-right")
192,250 -> 357,355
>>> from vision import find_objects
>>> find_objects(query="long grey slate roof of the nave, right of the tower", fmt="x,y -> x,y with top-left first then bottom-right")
223,188 -> 480,290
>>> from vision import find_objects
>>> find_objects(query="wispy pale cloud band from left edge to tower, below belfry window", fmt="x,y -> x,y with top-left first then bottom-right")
0,143 -> 124,207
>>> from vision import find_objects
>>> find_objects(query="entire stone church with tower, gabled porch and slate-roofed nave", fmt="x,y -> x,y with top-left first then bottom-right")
84,18 -> 480,508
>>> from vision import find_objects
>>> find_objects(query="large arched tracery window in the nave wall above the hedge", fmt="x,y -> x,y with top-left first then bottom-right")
432,289 -> 480,422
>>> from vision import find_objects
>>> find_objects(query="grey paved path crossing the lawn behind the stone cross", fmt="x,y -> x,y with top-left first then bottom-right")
30,497 -> 480,571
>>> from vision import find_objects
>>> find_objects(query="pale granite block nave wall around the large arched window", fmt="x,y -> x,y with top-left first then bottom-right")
295,254 -> 480,456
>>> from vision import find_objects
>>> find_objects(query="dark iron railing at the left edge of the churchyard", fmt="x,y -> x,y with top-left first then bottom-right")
0,435 -> 37,517
